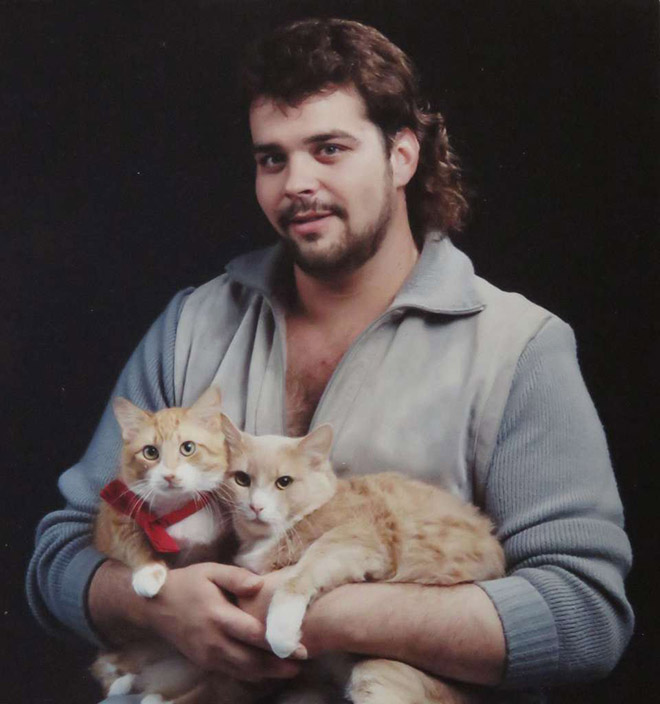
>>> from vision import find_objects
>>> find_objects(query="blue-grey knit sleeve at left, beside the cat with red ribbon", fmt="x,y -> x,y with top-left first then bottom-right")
26,291 -> 189,645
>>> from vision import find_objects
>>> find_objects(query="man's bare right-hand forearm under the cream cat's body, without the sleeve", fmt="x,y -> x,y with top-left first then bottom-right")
241,572 -> 506,685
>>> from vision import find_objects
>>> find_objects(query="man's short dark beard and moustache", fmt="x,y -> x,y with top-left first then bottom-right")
278,183 -> 393,279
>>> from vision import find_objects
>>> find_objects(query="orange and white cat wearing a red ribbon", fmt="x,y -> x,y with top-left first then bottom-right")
92,387 -> 228,702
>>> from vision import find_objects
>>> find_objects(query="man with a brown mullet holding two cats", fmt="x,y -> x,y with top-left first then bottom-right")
28,20 -> 632,696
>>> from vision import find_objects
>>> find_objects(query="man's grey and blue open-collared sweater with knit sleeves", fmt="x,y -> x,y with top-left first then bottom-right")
27,236 -> 632,687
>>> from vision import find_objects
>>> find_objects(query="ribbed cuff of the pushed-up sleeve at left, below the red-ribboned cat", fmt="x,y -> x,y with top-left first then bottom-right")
60,546 -> 108,647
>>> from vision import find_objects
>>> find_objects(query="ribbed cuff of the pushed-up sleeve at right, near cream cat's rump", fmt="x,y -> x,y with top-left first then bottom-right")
477,576 -> 559,688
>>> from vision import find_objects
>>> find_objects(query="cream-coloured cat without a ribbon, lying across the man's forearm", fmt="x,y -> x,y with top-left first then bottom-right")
223,416 -> 504,704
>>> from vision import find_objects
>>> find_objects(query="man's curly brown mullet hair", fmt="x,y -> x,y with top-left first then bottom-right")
243,19 -> 468,239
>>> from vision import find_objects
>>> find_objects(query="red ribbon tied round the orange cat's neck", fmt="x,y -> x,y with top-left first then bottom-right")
101,479 -> 209,552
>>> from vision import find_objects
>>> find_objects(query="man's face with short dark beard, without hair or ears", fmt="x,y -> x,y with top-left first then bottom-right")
250,88 -> 396,276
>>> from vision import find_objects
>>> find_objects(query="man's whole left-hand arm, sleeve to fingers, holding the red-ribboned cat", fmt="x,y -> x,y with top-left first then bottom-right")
27,292 -> 296,677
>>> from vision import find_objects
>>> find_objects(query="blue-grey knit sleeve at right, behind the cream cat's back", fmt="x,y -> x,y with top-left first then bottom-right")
480,318 -> 633,687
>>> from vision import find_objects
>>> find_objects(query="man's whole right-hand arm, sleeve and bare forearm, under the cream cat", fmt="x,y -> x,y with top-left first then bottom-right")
248,320 -> 632,687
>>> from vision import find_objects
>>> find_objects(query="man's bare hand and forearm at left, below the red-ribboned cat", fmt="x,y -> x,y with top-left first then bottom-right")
89,560 -> 299,681
